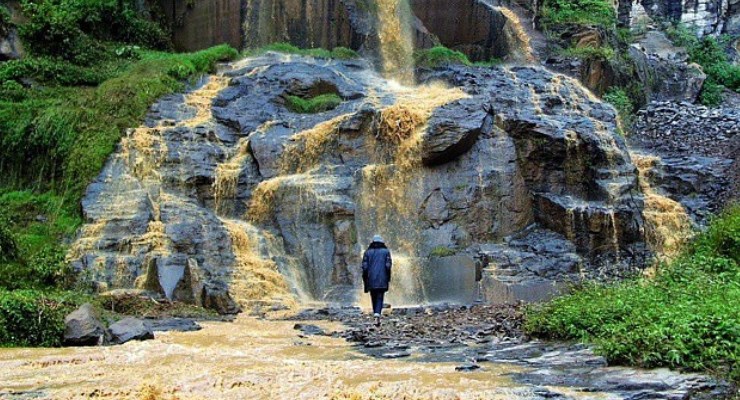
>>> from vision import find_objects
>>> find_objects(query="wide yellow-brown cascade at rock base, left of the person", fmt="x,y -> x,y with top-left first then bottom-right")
222,219 -> 295,307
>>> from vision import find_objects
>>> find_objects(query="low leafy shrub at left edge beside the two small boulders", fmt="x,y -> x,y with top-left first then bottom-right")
0,289 -> 76,346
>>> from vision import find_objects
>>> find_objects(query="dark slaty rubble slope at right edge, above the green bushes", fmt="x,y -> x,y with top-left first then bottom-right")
629,102 -> 740,222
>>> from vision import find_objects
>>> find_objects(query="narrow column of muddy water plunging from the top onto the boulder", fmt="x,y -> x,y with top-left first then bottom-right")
377,0 -> 415,85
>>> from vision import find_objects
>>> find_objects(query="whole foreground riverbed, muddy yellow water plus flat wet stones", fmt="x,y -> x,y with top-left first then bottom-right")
0,312 -> 726,400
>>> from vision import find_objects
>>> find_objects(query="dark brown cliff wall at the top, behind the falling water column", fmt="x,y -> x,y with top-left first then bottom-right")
158,0 -> 530,61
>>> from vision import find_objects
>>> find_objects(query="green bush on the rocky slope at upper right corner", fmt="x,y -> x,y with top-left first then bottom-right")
666,24 -> 740,106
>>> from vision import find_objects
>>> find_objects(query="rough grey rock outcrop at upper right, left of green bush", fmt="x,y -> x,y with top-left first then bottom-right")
629,31 -> 706,102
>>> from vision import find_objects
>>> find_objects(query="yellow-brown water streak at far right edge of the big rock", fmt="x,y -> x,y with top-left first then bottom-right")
632,153 -> 691,261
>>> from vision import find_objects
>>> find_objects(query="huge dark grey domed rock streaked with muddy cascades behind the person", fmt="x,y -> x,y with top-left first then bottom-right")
70,54 -> 644,312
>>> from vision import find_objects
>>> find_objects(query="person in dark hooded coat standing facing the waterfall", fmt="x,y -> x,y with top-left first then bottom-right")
362,235 -> 393,326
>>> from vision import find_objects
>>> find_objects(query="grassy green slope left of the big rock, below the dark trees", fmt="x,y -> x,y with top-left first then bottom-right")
0,46 -> 238,346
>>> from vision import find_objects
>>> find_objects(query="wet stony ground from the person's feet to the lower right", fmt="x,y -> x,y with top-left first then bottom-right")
282,305 -> 730,400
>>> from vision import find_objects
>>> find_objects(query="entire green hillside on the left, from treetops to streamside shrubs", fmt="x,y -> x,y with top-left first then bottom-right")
0,0 -> 238,346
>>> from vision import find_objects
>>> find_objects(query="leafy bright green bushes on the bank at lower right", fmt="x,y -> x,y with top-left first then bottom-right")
526,205 -> 740,382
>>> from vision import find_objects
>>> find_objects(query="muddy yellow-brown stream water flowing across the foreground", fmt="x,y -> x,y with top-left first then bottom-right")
0,316 -> 608,399
